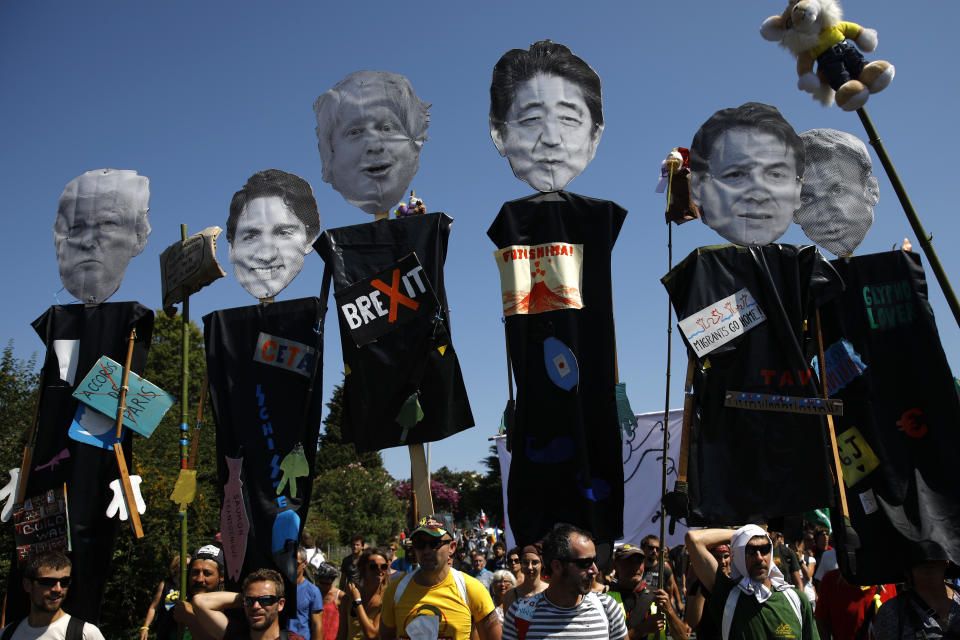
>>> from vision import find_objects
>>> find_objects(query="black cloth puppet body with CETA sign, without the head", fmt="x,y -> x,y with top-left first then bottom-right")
203,298 -> 326,611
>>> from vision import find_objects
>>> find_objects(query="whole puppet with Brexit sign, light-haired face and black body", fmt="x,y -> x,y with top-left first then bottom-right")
313,71 -> 473,451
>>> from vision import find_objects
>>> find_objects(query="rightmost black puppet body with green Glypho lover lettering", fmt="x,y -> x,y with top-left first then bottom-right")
821,251 -> 960,585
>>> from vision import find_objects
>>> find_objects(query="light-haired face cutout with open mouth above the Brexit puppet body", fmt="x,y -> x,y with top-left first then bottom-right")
314,71 -> 428,213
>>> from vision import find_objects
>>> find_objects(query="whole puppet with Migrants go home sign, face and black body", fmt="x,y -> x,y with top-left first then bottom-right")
662,103 -> 842,525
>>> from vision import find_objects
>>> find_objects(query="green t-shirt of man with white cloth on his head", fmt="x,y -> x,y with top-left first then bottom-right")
707,569 -> 820,640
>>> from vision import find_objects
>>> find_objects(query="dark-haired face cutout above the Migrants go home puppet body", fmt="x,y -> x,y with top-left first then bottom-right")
690,103 -> 803,246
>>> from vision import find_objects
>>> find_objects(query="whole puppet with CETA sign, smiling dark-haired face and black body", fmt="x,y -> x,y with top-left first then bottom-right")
203,169 -> 326,602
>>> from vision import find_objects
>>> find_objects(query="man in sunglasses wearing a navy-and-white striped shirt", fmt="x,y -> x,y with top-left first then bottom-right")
503,523 -> 627,640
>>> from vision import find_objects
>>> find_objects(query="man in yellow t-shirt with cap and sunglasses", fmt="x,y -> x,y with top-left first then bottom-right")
380,516 -> 500,640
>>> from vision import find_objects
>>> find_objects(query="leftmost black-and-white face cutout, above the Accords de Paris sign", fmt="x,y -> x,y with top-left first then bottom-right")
53,169 -> 150,304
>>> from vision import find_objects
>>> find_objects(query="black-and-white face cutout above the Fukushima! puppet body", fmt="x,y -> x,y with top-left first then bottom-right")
490,40 -> 603,192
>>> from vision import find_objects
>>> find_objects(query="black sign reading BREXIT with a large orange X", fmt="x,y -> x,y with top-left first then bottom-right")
334,253 -> 440,347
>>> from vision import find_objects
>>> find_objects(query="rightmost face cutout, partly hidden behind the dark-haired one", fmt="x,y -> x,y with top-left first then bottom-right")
794,129 -> 880,256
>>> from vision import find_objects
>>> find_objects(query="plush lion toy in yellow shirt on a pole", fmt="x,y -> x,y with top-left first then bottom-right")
760,0 -> 894,111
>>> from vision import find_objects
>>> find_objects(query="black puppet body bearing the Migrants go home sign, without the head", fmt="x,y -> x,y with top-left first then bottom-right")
662,244 -> 843,526
